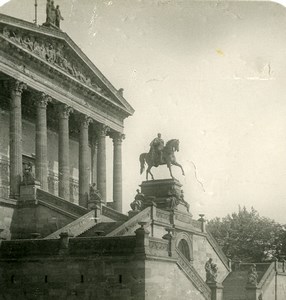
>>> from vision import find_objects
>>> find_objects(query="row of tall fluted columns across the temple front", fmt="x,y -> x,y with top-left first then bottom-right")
7,80 -> 124,211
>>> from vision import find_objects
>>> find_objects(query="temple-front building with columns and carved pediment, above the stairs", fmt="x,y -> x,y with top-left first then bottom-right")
0,15 -> 134,211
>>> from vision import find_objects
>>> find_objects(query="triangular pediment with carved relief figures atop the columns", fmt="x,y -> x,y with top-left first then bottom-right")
0,14 -> 134,115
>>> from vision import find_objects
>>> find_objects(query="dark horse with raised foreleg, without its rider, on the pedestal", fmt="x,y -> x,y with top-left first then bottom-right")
139,139 -> 185,180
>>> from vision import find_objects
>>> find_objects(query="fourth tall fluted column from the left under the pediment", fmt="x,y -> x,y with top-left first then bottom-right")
78,116 -> 91,208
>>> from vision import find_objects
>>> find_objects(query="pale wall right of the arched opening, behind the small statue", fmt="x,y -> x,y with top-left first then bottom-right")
193,235 -> 229,282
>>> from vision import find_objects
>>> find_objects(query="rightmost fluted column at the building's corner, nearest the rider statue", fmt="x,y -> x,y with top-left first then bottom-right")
112,132 -> 125,212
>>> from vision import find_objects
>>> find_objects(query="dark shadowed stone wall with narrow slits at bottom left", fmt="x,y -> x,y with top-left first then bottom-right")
0,237 -> 145,300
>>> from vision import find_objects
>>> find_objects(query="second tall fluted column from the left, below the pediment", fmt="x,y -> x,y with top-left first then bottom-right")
35,93 -> 51,190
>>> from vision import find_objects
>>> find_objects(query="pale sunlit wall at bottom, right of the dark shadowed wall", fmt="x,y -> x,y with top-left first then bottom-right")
145,260 -> 204,300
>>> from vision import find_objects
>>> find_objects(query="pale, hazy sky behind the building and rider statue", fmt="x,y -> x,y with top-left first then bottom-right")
0,0 -> 286,223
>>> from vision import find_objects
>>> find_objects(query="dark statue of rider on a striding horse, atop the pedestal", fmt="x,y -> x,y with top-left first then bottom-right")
139,133 -> 185,180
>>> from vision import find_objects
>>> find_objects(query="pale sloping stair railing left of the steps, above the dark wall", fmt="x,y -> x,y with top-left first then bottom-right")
45,210 -> 96,239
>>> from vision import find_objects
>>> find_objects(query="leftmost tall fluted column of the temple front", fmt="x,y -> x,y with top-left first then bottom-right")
10,81 -> 27,199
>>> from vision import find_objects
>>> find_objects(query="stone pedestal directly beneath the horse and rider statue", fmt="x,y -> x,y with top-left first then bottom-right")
140,179 -> 189,212
